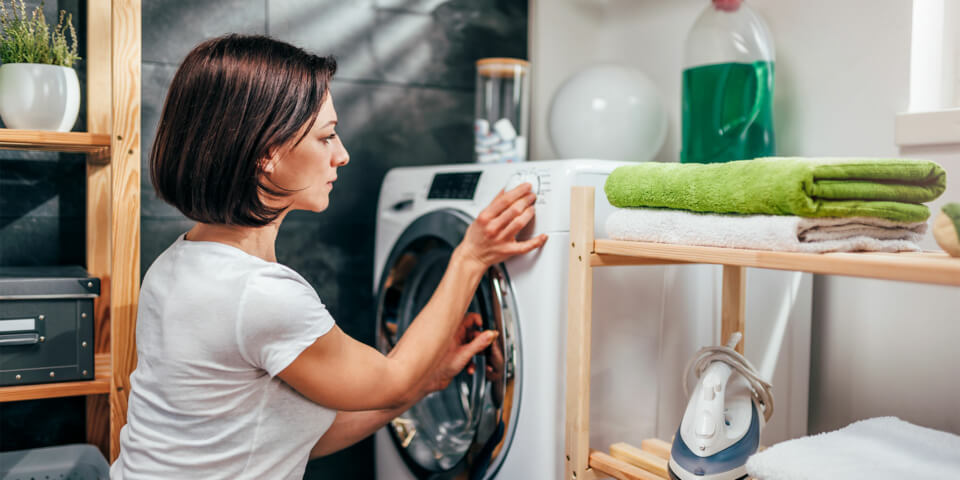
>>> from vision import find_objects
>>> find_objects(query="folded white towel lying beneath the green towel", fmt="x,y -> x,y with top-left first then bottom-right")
606,208 -> 927,253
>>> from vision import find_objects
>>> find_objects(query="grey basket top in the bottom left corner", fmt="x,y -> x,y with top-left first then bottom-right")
0,444 -> 110,480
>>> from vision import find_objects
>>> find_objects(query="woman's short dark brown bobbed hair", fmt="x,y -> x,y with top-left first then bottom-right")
150,35 -> 337,226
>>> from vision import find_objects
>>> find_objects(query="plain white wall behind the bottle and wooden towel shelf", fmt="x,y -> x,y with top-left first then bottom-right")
530,0 -> 960,433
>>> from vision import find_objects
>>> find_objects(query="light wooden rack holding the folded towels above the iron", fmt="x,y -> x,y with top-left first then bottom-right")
564,187 -> 960,480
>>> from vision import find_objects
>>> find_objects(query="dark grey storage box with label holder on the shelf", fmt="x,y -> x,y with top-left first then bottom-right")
0,267 -> 100,386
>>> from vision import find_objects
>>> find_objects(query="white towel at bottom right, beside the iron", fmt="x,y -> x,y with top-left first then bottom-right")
747,417 -> 960,480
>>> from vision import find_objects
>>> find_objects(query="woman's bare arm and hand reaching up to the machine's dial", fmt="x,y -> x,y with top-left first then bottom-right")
279,184 -> 546,411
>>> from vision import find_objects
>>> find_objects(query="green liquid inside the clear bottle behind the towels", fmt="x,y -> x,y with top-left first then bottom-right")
680,61 -> 776,163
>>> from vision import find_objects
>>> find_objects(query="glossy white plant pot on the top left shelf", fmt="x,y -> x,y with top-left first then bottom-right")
0,63 -> 80,132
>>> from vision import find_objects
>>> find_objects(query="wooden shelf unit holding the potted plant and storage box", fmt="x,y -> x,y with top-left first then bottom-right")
0,0 -> 141,462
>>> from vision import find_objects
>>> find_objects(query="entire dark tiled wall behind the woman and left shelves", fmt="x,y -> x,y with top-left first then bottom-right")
0,0 -> 527,472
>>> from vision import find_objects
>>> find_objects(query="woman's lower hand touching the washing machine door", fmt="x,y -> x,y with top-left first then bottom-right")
421,312 -> 497,395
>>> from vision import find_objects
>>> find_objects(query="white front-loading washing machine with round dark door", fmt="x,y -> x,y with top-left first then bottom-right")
373,160 -> 809,480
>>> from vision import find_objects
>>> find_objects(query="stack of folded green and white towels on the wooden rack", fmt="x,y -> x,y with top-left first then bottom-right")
604,158 -> 946,252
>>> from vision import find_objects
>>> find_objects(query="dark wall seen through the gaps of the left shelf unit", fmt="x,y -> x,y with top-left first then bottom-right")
0,0 -> 86,451
